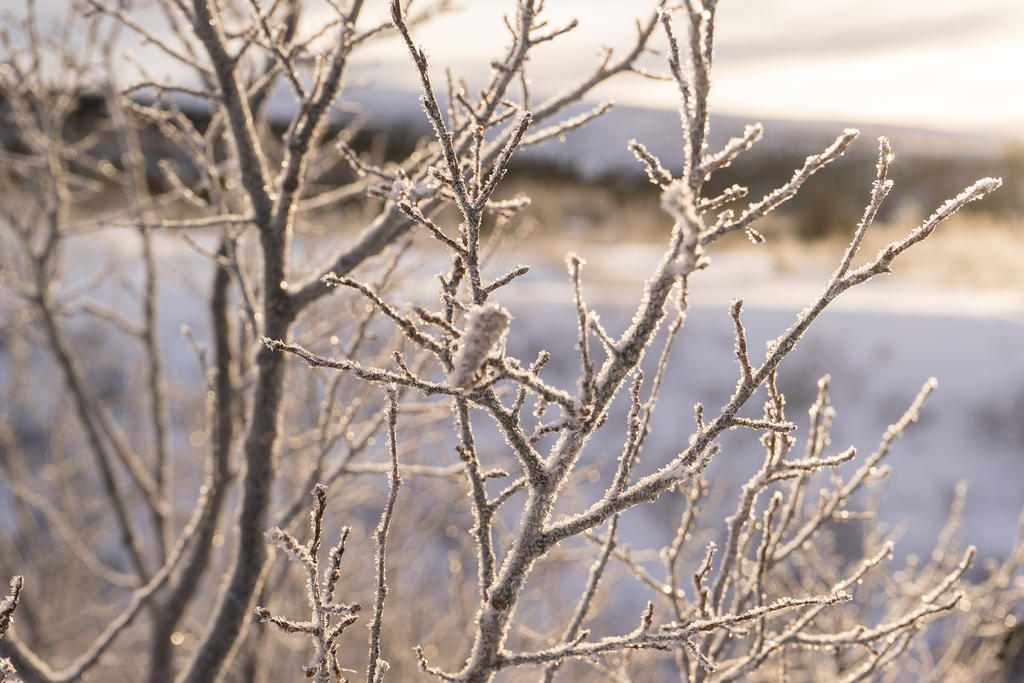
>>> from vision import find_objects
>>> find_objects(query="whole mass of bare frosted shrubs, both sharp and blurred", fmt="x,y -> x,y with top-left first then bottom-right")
0,0 -> 1024,682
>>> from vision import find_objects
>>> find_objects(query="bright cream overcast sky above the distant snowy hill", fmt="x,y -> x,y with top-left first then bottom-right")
335,0 -> 1024,140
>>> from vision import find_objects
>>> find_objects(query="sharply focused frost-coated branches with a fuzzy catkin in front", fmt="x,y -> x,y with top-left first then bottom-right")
271,2 -> 1021,681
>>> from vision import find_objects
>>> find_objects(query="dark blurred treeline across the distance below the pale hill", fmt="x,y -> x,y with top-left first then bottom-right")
6,92 -> 1024,239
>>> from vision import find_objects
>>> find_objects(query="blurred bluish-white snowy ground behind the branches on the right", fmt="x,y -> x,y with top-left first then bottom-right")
477,244 -> 1024,556
